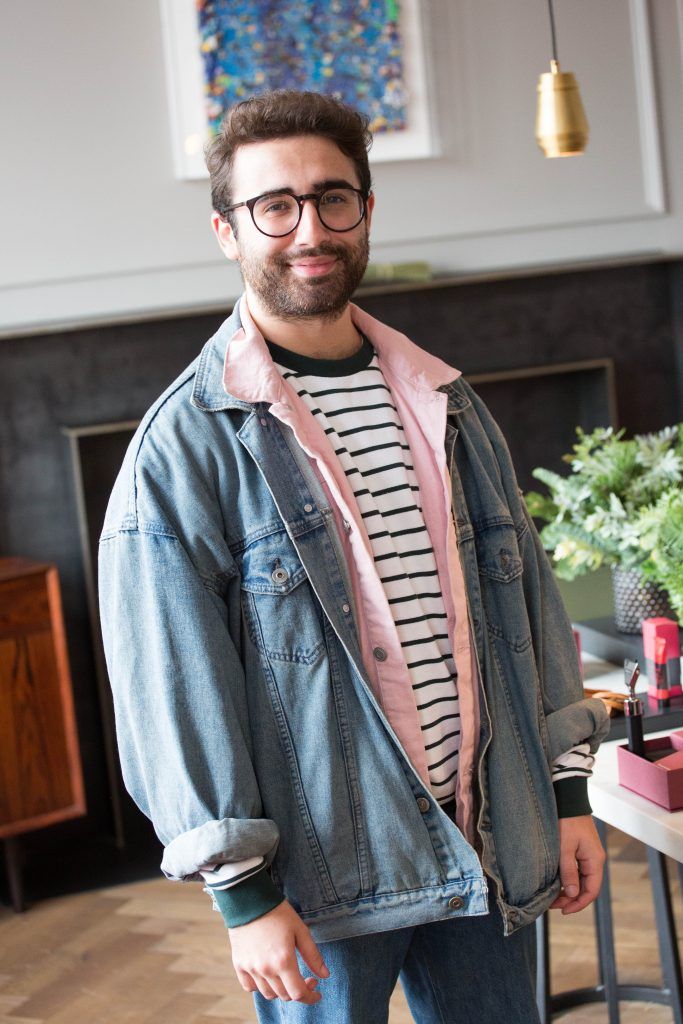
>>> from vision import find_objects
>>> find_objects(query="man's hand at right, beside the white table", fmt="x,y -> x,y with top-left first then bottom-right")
549,814 -> 606,913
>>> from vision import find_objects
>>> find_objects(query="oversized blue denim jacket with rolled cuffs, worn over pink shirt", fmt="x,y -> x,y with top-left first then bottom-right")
99,299 -> 609,941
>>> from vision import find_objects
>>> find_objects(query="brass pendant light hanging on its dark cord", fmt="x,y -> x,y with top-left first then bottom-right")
536,0 -> 588,157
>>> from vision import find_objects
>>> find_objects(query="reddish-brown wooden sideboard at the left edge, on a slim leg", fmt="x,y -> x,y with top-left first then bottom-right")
0,558 -> 86,911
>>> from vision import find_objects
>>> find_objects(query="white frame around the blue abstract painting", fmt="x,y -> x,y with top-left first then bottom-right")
160,0 -> 437,179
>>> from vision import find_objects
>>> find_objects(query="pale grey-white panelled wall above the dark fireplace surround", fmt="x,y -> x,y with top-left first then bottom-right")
0,0 -> 683,334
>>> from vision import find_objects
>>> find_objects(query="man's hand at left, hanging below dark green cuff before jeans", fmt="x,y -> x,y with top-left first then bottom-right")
227,900 -> 330,1004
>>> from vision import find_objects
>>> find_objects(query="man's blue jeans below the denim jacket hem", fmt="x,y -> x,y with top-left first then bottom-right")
253,804 -> 540,1024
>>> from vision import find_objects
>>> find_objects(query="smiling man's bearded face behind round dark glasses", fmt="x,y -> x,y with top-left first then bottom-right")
212,135 -> 374,321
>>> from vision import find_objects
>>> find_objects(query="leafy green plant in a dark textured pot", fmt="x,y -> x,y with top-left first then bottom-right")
525,424 -> 683,633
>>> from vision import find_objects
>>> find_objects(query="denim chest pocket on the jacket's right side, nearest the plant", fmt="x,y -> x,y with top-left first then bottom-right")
475,521 -> 531,651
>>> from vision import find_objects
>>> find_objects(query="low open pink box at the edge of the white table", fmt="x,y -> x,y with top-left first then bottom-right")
616,729 -> 683,811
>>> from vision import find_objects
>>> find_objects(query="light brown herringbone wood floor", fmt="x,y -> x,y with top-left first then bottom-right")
0,828 -> 683,1024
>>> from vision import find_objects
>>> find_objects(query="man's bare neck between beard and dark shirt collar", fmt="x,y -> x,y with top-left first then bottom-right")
247,293 -> 361,359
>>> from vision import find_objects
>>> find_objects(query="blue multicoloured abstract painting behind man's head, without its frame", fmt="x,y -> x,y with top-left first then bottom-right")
196,0 -> 408,133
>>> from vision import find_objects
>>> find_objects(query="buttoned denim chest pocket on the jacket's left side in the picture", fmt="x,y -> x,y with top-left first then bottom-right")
236,530 -> 325,665
